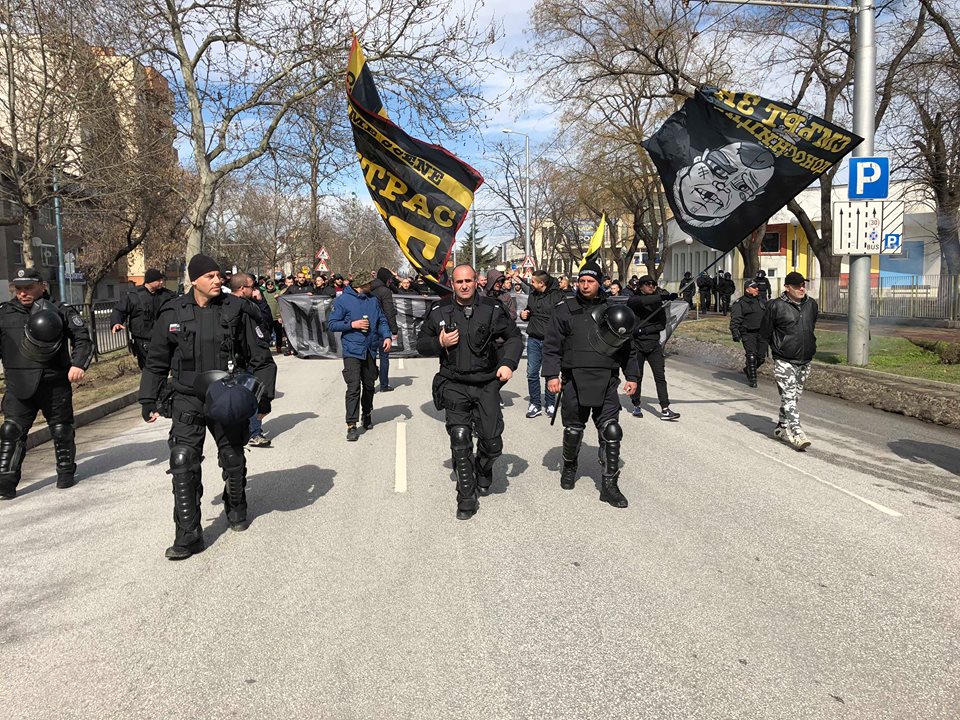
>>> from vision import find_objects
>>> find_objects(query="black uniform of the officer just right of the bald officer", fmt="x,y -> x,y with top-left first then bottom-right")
540,292 -> 639,507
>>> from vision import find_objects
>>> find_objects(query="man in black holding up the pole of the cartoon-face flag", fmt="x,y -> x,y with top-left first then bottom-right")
627,275 -> 680,420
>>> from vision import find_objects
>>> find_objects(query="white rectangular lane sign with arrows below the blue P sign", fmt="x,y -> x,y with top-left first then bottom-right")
833,200 -> 903,255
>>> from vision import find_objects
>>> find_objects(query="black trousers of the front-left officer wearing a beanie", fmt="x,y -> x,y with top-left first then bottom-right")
168,393 -> 250,541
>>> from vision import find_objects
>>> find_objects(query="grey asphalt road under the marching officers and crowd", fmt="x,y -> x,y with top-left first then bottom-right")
0,357 -> 960,720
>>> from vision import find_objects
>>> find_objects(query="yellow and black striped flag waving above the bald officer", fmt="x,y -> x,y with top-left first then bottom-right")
347,38 -> 483,286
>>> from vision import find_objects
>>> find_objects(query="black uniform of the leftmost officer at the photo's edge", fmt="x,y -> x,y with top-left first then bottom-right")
0,298 -> 93,498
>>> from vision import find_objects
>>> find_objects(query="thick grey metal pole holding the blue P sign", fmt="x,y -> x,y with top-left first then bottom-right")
847,0 -> 877,365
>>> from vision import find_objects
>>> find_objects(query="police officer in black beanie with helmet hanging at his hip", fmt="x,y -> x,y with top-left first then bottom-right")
139,255 -> 277,560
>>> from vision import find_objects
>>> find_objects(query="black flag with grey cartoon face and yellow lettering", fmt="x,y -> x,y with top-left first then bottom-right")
643,88 -> 863,252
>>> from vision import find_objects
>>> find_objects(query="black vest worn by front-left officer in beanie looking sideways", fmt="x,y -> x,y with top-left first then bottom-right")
169,295 -> 249,393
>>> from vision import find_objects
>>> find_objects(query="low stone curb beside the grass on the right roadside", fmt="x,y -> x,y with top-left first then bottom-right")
671,336 -> 960,428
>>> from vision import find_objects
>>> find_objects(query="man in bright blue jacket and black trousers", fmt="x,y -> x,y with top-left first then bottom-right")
327,278 -> 393,442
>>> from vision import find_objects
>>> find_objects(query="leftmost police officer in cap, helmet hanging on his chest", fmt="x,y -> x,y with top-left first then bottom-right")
0,268 -> 93,500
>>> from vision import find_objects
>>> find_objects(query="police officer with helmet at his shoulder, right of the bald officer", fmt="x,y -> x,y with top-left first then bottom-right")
541,260 -> 639,508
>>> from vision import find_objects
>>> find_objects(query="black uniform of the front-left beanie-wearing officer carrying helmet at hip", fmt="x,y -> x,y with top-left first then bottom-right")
139,292 -> 277,557
